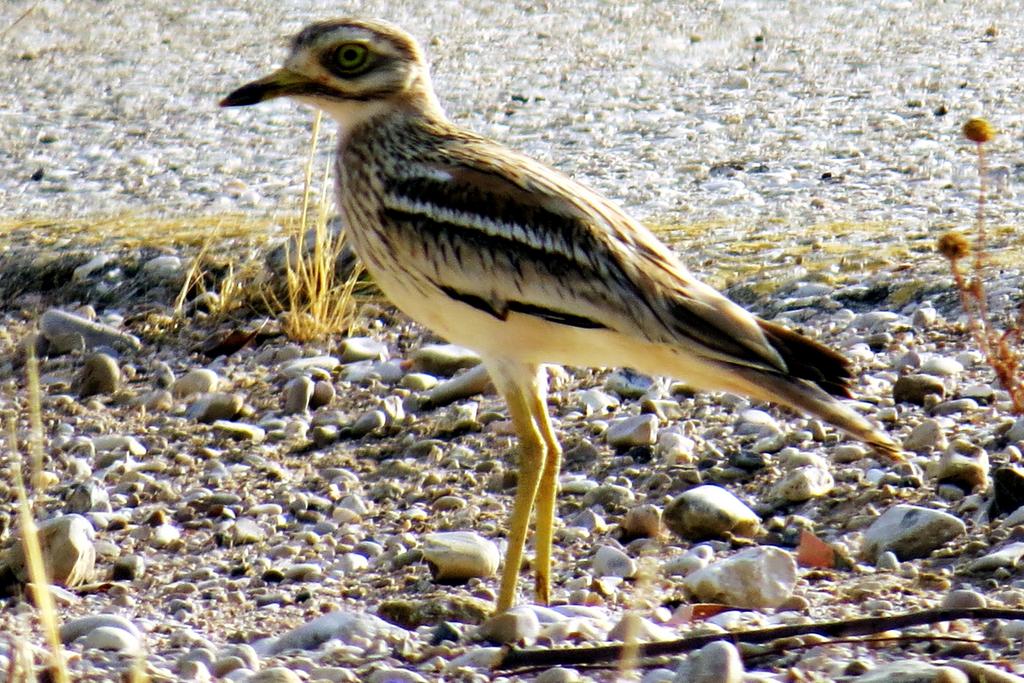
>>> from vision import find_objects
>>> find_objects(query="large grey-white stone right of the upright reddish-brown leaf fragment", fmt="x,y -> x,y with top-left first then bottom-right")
860,504 -> 967,561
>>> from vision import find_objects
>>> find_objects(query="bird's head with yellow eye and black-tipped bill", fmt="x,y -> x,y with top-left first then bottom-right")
220,18 -> 440,126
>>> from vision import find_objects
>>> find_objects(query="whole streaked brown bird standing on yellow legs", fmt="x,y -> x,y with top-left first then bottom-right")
221,18 -> 898,610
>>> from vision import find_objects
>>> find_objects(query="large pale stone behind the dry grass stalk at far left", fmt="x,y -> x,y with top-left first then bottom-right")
3,514 -> 96,588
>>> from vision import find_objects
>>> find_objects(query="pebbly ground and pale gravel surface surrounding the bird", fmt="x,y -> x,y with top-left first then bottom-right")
0,0 -> 1024,683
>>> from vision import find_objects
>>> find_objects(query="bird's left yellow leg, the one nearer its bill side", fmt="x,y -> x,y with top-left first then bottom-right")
492,373 -> 547,613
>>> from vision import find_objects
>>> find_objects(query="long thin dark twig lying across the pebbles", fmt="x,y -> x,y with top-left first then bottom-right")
495,607 -> 1024,671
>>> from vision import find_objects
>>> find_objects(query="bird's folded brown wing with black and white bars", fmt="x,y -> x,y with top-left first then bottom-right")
384,132 -> 785,371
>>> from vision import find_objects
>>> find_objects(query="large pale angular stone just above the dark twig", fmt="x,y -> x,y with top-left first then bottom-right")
683,546 -> 797,609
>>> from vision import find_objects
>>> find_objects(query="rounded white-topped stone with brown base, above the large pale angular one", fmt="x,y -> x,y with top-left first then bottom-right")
664,485 -> 761,541
